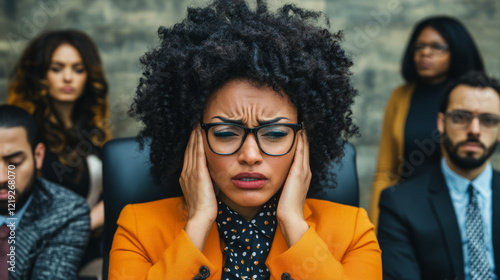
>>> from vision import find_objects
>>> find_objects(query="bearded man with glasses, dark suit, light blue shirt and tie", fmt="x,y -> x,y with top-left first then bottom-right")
378,72 -> 500,280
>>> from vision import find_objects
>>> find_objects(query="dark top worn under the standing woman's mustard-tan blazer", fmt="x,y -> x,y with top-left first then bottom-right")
401,81 -> 448,179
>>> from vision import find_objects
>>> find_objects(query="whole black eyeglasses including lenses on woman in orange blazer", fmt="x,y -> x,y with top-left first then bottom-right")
201,123 -> 302,156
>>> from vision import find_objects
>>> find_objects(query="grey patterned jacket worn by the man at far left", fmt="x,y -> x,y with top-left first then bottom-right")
9,178 -> 90,280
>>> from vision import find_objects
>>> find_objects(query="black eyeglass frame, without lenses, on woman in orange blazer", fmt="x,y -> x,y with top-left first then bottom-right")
201,122 -> 302,157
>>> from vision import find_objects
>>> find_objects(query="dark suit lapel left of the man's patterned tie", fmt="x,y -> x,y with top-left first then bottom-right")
429,168 -> 465,279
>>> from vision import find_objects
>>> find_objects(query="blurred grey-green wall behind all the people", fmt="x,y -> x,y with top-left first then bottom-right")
0,0 -> 500,208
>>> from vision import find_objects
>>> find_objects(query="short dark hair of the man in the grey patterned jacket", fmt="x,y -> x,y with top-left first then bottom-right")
0,105 -> 38,149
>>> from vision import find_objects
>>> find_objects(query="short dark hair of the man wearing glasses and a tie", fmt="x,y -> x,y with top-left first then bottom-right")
439,71 -> 500,113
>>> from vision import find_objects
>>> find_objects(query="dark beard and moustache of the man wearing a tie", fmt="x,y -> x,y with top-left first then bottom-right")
441,130 -> 497,170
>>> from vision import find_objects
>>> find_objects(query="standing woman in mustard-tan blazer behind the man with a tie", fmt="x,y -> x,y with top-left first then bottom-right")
370,16 -> 484,224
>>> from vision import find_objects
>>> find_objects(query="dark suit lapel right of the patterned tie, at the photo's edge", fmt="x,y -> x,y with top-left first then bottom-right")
491,171 -> 500,277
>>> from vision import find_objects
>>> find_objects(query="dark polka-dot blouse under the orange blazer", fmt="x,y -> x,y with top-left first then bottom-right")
216,195 -> 278,280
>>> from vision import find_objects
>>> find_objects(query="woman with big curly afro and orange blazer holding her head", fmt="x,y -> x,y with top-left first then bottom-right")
109,0 -> 382,280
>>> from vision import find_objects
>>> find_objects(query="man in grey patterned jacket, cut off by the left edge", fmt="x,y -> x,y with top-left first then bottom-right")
0,105 -> 90,280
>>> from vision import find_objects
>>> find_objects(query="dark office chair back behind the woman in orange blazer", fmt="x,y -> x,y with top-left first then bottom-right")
103,138 -> 359,280
